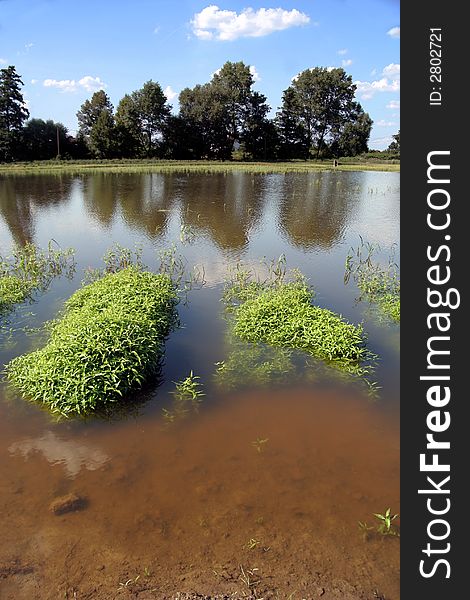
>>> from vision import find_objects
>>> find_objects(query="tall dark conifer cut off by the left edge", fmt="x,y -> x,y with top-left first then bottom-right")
0,66 -> 29,161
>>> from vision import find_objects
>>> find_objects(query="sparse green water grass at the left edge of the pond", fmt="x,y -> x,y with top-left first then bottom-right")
0,241 -> 75,316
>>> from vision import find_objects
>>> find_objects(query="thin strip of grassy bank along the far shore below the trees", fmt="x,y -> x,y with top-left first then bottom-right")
0,158 -> 400,175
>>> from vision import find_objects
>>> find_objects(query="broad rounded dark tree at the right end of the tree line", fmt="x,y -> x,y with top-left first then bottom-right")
279,67 -> 368,157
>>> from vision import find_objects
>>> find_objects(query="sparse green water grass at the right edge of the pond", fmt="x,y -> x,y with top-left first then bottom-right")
344,238 -> 400,323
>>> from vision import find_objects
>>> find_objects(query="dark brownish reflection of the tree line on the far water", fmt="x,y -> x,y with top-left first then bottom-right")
0,172 -> 393,251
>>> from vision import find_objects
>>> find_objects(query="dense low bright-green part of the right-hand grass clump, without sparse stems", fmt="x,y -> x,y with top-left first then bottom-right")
233,281 -> 366,374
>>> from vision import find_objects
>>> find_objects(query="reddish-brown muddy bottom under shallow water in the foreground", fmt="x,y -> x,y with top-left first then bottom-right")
0,389 -> 400,600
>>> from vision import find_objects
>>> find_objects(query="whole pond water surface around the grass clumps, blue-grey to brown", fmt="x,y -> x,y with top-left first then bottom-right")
0,172 -> 399,600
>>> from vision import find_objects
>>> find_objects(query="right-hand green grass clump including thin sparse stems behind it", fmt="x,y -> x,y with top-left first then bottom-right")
224,257 -> 371,376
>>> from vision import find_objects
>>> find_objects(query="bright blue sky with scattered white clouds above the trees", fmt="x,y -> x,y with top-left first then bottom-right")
0,0 -> 400,150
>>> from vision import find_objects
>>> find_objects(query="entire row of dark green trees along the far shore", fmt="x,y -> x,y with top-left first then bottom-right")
0,62 -> 378,162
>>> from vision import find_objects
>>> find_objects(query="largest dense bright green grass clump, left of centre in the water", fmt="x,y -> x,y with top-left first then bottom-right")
6,266 -> 178,416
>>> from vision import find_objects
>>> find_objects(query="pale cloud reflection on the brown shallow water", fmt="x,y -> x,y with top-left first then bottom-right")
8,431 -> 109,478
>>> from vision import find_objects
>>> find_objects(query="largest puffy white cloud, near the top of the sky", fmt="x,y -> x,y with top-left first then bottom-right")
191,5 -> 310,41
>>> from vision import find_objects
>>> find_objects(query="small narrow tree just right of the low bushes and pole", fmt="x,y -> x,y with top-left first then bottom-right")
77,90 -> 115,158
